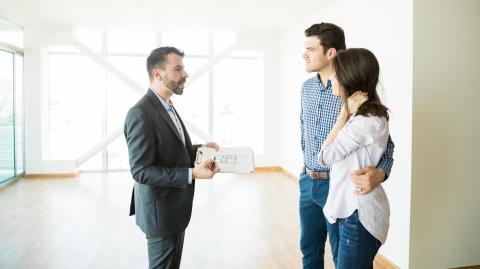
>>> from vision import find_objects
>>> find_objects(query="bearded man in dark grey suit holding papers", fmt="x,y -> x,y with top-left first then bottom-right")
125,47 -> 219,268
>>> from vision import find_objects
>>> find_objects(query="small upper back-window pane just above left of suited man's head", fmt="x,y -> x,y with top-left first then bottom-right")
107,31 -> 157,55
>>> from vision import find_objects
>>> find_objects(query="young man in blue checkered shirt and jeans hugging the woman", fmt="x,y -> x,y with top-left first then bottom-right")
299,23 -> 394,269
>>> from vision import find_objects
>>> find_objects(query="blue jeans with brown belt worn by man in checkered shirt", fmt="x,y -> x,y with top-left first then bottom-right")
299,173 -> 339,269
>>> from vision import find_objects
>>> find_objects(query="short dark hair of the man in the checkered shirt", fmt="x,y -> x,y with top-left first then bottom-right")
305,22 -> 347,54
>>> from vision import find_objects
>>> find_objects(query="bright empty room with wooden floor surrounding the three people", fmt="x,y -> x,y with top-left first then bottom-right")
0,0 -> 480,269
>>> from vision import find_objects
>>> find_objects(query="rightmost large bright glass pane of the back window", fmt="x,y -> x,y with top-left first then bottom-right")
213,54 -> 264,154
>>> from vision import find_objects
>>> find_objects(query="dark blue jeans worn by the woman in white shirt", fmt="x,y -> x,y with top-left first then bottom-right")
337,210 -> 382,269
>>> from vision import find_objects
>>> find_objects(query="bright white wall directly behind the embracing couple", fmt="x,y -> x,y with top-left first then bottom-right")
280,0 -> 412,268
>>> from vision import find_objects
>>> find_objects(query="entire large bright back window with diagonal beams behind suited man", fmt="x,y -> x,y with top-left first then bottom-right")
47,30 -> 263,170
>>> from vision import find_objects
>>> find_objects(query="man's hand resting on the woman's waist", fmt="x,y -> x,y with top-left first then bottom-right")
352,167 -> 385,195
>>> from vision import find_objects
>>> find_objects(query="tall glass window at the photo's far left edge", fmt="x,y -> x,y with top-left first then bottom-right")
0,18 -> 25,184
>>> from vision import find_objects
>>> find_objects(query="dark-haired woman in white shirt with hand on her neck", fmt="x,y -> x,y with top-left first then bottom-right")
318,48 -> 390,269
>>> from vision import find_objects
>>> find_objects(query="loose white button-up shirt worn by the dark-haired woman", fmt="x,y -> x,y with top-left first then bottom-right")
318,115 -> 390,244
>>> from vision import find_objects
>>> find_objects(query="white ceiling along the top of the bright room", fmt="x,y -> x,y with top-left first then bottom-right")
0,0 -> 332,32
